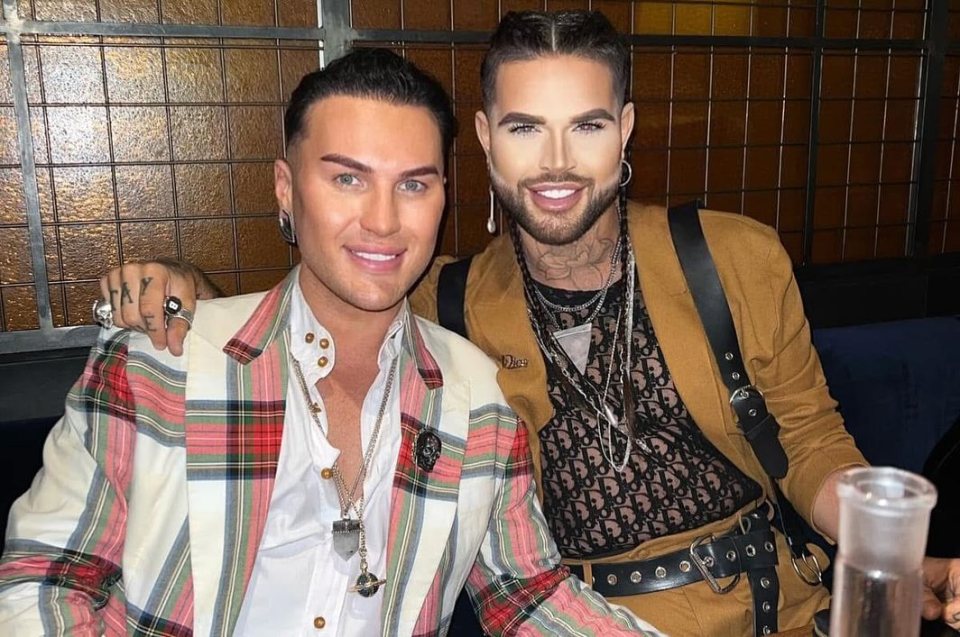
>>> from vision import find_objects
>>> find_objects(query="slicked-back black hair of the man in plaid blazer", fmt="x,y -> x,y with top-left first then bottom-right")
283,48 -> 457,159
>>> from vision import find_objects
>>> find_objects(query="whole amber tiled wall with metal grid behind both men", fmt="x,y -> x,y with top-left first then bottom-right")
0,0 -> 960,338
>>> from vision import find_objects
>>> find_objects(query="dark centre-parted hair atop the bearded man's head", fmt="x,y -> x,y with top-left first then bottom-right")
480,11 -> 630,113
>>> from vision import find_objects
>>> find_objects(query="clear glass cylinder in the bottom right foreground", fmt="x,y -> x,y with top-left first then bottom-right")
830,467 -> 937,637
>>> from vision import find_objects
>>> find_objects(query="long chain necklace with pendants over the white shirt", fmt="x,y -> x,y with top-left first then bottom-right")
291,358 -> 397,597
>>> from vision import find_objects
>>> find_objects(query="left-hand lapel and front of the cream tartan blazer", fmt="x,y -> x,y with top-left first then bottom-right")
185,270 -> 296,636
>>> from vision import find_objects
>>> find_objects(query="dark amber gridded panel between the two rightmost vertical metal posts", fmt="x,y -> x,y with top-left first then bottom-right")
812,50 -> 923,263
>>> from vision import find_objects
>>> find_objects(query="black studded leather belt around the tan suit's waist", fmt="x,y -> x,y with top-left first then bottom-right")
568,505 -> 780,635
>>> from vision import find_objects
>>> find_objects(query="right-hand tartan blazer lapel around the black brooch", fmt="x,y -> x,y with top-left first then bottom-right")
382,314 -> 470,636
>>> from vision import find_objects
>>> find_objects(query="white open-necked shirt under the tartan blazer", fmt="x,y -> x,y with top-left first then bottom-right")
235,283 -> 409,637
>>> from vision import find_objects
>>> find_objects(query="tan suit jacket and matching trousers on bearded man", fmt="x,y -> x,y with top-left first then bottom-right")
411,203 -> 866,635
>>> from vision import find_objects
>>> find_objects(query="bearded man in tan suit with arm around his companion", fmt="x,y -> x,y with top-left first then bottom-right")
97,12 -> 960,636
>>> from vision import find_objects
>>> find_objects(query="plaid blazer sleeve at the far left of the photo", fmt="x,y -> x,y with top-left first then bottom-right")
0,332 -> 135,635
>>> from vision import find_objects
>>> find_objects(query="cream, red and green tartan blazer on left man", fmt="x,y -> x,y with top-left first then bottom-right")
0,269 -> 658,636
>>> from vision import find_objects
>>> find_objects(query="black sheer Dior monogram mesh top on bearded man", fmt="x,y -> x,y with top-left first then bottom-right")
537,279 -> 761,559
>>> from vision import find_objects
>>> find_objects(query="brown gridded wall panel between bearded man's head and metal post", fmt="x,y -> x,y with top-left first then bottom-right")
630,47 -> 811,260
